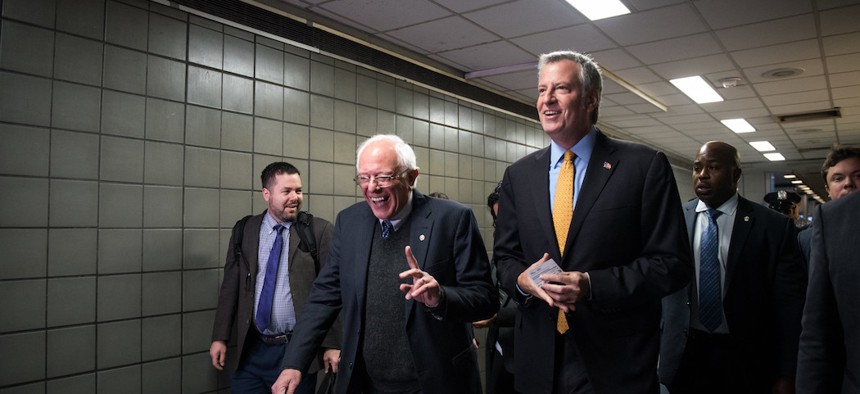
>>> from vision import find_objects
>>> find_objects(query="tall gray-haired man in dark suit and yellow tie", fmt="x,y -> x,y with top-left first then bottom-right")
493,52 -> 692,394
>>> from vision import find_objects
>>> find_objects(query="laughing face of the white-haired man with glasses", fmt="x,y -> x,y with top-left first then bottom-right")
358,140 -> 418,220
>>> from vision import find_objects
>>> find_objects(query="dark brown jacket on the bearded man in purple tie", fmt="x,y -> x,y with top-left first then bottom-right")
212,211 -> 340,373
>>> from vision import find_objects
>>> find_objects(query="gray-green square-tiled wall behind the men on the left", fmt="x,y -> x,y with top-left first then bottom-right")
0,0 -> 548,394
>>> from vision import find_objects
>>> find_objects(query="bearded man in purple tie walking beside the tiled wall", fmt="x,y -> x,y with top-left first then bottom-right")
209,162 -> 340,393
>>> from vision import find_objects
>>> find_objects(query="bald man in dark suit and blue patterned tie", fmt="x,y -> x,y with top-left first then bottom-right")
660,142 -> 806,394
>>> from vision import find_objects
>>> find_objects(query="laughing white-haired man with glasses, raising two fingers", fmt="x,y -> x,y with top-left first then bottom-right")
272,135 -> 499,394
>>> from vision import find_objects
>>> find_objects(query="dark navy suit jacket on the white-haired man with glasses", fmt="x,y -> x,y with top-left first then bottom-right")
283,190 -> 499,394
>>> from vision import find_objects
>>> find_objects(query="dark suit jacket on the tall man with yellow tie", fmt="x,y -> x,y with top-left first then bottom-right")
493,131 -> 692,393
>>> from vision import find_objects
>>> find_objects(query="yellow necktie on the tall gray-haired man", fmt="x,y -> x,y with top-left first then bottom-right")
552,150 -> 576,334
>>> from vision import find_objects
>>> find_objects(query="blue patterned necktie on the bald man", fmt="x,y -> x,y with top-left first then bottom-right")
699,209 -> 723,331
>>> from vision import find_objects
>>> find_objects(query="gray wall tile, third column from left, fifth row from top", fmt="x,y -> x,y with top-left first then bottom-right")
98,183 -> 143,228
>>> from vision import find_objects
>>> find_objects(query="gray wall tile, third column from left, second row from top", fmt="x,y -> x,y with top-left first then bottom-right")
103,45 -> 146,94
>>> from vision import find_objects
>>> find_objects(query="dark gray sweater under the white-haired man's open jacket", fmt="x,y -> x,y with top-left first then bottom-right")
362,223 -> 420,393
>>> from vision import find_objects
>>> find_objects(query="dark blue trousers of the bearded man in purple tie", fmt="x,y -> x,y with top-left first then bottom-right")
230,333 -> 317,394
